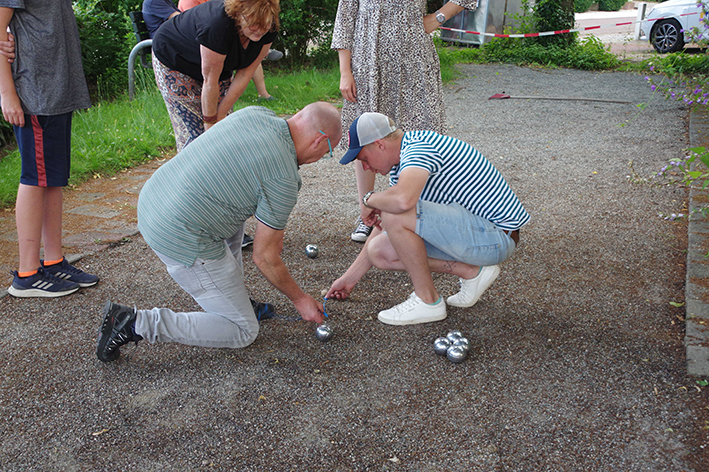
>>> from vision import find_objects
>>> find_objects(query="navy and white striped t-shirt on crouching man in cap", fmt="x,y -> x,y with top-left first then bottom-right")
389,131 -> 529,230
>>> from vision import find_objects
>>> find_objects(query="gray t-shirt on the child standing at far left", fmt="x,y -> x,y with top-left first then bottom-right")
0,0 -> 91,116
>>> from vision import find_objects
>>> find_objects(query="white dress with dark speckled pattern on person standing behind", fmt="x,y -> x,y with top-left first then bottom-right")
331,0 -> 478,148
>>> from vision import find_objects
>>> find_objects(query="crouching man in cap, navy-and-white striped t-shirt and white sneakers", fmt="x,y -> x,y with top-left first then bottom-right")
327,113 -> 529,325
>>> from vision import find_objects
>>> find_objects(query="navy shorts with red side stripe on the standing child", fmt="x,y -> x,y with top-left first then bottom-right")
13,112 -> 72,187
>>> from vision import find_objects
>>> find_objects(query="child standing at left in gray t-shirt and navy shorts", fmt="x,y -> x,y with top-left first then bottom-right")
0,0 -> 98,297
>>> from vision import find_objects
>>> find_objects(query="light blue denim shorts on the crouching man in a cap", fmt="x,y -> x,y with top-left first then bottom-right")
416,200 -> 515,266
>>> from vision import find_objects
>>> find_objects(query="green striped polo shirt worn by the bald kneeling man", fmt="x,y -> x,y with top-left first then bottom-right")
138,107 -> 301,266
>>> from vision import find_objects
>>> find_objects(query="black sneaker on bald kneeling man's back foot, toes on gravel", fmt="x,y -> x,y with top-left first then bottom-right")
96,301 -> 143,362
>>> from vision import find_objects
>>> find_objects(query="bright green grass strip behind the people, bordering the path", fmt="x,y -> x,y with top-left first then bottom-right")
0,67 -> 341,208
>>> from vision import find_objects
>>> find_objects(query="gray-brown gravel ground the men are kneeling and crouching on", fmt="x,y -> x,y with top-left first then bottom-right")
0,65 -> 709,471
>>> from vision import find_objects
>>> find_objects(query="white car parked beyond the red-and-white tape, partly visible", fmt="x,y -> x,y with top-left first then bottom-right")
640,0 -> 709,54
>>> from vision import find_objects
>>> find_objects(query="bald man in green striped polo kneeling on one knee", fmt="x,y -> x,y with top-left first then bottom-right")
97,102 -> 342,362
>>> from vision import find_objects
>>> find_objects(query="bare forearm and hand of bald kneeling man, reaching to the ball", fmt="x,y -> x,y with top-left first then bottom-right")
253,221 -> 324,323
